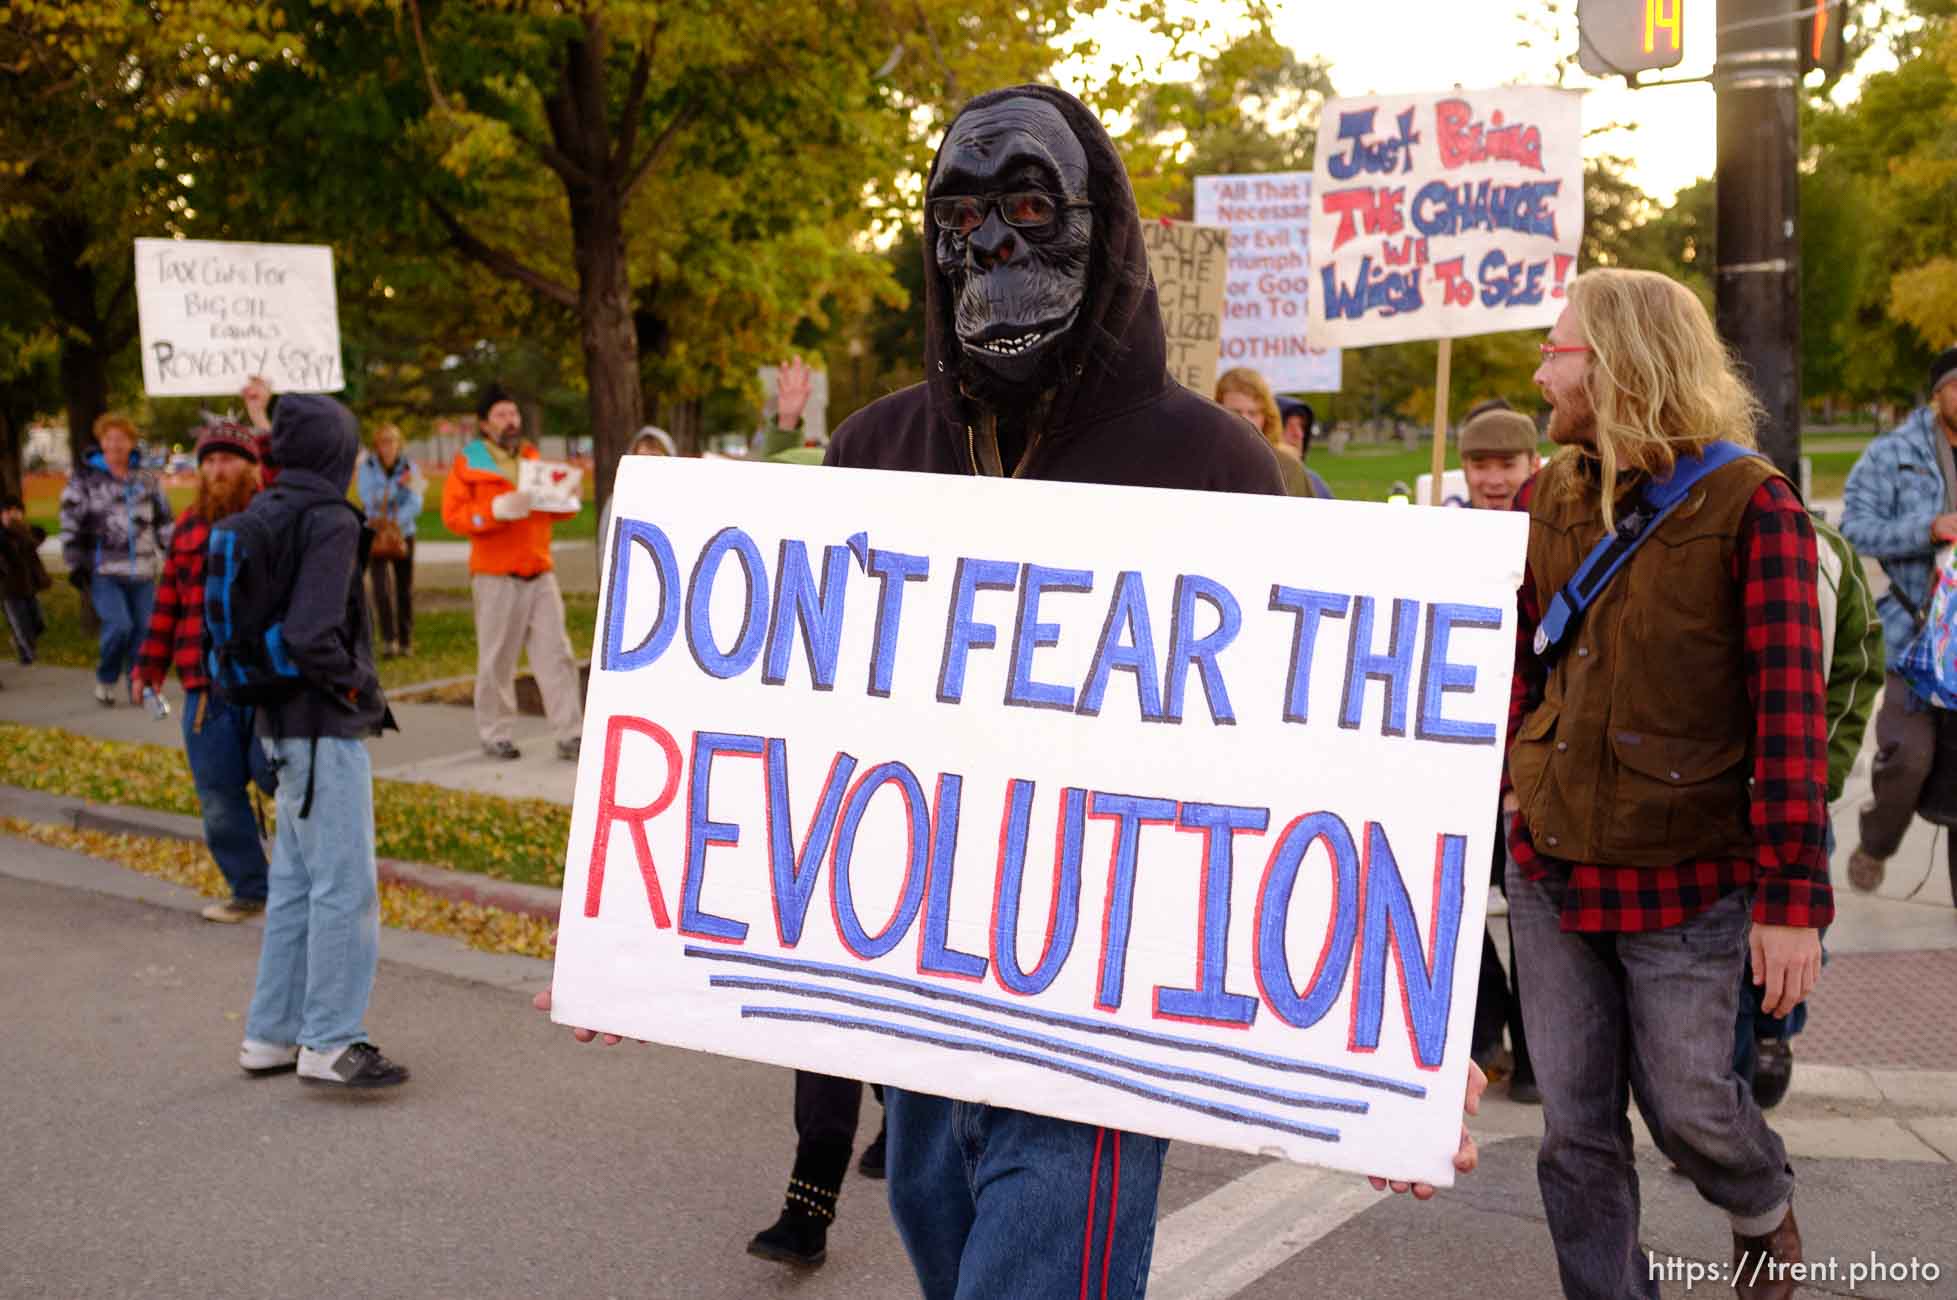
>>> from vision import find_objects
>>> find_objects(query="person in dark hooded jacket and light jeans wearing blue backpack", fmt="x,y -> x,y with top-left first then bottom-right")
239,394 -> 407,1089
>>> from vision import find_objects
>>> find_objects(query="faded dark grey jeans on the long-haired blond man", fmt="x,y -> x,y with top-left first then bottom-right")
1509,867 -> 1795,1300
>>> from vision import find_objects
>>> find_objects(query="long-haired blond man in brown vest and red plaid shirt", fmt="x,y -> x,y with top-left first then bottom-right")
1509,270 -> 1834,1300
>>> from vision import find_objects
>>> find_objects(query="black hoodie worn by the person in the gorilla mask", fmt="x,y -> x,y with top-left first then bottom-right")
824,86 -> 1284,495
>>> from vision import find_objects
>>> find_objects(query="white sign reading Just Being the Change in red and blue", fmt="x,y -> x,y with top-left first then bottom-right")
1311,86 -> 1583,347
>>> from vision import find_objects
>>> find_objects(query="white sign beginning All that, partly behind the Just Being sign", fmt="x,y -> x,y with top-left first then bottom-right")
1196,172 -> 1341,394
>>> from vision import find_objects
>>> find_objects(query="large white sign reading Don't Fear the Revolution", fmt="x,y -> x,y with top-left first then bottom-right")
554,456 -> 1526,1184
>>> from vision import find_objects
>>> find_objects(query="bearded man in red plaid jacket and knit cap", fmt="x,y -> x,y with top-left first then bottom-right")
129,421 -> 276,924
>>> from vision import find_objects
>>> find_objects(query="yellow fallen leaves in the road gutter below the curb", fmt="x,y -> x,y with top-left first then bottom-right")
0,816 -> 558,959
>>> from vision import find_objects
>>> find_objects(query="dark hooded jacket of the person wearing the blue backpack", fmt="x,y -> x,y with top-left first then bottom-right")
249,394 -> 393,740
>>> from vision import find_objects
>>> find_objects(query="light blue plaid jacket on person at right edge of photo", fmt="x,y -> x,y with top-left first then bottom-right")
1842,407 -> 1943,672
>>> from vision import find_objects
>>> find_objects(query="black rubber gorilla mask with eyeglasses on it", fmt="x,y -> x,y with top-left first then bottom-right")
926,96 -> 1094,395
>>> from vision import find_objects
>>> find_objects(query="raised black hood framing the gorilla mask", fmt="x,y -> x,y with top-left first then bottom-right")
924,84 -> 1168,435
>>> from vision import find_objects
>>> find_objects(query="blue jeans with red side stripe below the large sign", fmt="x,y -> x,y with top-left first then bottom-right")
885,1089 -> 1168,1300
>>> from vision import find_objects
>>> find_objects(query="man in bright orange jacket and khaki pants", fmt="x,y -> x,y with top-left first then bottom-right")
442,384 -> 583,760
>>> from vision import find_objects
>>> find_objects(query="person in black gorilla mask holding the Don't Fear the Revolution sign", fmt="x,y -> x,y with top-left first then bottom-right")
826,86 -> 1476,1300
